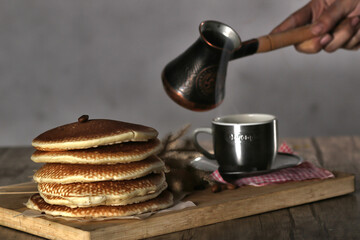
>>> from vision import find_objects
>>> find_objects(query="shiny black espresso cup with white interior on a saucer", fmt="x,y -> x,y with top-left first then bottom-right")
193,114 -> 278,174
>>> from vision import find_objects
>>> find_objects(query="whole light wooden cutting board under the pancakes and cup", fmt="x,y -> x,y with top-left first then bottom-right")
0,172 -> 355,240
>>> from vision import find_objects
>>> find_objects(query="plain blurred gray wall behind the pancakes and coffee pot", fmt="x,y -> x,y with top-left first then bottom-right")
0,0 -> 360,146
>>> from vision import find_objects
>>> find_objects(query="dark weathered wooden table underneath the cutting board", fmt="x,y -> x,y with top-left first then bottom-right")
0,136 -> 360,240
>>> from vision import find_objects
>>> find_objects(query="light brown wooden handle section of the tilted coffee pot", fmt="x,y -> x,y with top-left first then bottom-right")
256,25 -> 315,53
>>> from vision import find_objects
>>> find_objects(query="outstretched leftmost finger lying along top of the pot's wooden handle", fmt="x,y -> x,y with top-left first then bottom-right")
271,3 -> 311,33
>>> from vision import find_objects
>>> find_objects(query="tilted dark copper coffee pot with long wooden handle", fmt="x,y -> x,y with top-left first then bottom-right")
162,21 -> 314,111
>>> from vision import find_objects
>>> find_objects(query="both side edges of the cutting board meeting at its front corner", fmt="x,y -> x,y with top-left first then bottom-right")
0,172 -> 355,240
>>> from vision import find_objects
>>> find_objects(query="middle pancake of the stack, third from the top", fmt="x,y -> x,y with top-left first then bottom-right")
33,155 -> 165,184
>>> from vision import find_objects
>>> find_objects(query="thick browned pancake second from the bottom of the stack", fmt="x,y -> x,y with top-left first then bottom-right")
38,173 -> 167,205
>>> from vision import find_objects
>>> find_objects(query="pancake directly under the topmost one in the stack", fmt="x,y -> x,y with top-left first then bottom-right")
31,138 -> 162,164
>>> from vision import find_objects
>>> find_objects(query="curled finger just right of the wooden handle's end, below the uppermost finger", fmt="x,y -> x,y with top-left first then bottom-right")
324,18 -> 355,53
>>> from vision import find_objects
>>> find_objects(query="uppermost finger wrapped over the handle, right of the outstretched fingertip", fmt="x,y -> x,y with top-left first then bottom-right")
311,0 -> 356,36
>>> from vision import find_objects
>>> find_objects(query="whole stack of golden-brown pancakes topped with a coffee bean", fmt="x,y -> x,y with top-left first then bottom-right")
26,115 -> 173,217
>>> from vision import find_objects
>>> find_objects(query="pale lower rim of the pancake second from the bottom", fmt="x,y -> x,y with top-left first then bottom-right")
40,182 -> 167,208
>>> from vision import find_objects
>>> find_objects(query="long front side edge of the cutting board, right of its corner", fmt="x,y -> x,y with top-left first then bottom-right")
86,172 -> 355,240
